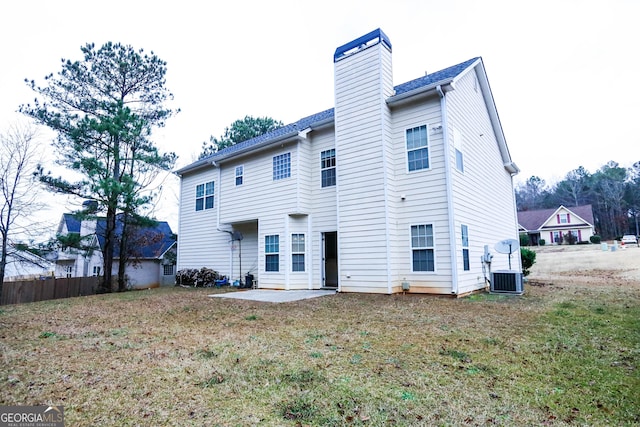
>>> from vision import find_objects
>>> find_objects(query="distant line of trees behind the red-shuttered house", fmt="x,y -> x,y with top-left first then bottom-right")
515,161 -> 640,239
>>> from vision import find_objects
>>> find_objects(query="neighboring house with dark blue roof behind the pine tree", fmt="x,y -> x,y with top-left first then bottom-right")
56,214 -> 176,289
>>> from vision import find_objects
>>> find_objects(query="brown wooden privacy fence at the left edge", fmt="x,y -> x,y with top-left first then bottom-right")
0,277 -> 100,305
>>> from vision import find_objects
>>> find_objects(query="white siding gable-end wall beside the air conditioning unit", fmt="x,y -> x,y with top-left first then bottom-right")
447,72 -> 520,293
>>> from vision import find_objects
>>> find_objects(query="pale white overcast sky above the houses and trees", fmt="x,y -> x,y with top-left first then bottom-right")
0,0 -> 640,231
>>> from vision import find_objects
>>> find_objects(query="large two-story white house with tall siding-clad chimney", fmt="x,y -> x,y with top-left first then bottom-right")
176,30 -> 520,295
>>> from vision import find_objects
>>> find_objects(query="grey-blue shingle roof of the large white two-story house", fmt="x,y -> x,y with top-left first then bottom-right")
175,57 -> 488,175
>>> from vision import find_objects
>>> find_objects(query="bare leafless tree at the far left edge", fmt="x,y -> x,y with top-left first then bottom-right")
0,123 -> 42,295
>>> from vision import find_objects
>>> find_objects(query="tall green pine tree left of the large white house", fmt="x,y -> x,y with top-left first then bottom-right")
20,42 -> 176,292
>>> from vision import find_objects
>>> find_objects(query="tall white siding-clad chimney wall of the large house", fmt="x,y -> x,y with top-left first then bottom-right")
335,44 -> 393,293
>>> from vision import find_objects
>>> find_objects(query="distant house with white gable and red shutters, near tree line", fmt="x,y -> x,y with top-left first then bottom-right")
518,205 -> 594,246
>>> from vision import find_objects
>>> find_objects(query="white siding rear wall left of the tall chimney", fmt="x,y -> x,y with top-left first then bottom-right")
177,132 -> 337,289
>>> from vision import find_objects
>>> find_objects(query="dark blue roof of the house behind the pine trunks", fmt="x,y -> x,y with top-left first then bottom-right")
96,214 -> 176,259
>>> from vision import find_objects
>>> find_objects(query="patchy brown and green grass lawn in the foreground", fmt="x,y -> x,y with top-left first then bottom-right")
0,284 -> 640,426
